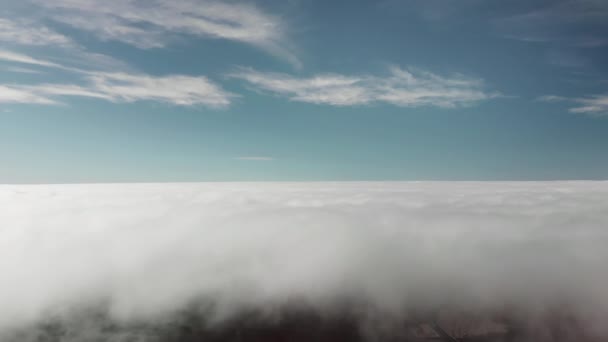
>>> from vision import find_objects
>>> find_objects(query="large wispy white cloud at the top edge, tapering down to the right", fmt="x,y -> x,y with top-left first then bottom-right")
31,0 -> 300,66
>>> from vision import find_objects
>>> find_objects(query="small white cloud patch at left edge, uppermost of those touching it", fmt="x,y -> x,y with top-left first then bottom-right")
0,18 -> 72,46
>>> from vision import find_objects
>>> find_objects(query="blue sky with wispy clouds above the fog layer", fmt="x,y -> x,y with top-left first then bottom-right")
0,0 -> 608,183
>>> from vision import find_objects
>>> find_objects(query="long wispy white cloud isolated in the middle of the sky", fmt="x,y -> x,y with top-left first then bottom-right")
229,66 -> 498,108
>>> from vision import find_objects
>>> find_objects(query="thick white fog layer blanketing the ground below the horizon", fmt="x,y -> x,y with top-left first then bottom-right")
0,182 -> 608,341
